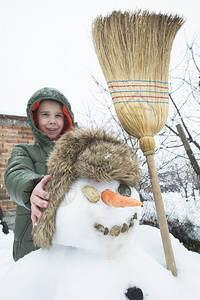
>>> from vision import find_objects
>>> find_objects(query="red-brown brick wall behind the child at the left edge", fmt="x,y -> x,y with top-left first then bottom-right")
0,114 -> 34,212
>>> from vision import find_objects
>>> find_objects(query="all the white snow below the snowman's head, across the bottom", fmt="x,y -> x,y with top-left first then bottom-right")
0,225 -> 200,300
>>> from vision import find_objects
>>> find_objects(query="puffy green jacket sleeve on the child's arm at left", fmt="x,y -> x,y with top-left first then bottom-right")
4,145 -> 44,210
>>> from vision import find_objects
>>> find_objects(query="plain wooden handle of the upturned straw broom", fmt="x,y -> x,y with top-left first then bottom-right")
146,154 -> 177,276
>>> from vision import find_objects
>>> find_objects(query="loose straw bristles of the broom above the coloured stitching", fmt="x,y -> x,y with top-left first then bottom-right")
92,10 -> 183,81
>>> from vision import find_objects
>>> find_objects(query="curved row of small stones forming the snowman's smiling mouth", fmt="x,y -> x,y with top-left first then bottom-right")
94,213 -> 138,236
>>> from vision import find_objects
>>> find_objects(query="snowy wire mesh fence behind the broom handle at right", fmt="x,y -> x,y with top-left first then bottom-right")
141,190 -> 200,251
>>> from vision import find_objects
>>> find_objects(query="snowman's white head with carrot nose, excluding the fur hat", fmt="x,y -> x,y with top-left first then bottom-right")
53,178 -> 142,254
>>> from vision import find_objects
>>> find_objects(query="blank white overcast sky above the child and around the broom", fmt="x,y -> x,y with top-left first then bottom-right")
0,0 -> 200,117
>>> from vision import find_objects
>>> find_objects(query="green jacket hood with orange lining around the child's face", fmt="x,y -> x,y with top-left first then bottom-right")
26,87 -> 74,144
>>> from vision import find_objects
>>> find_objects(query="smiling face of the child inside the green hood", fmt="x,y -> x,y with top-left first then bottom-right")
36,100 -> 64,140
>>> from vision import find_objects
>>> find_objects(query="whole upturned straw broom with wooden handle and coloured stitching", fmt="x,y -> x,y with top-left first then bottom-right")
92,10 -> 184,276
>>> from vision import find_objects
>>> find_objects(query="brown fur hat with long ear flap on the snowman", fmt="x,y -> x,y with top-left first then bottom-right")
33,128 -> 141,248
